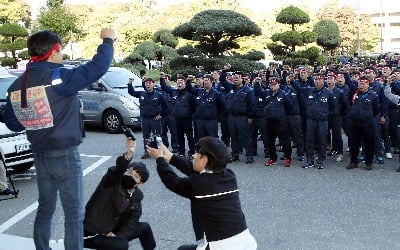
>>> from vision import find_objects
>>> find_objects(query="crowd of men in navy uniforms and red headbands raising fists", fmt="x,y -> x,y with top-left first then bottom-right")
128,54 -> 400,172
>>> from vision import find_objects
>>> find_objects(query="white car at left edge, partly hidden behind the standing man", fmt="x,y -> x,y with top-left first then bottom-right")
0,68 -> 33,172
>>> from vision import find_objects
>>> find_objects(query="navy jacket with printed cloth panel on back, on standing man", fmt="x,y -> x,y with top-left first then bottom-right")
3,38 -> 114,152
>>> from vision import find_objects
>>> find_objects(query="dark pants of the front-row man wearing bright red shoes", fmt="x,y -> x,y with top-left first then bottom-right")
266,119 -> 292,161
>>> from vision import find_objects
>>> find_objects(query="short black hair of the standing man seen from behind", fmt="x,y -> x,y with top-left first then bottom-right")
27,30 -> 62,56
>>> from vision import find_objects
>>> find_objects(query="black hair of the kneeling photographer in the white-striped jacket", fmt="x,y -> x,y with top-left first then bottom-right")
195,136 -> 229,172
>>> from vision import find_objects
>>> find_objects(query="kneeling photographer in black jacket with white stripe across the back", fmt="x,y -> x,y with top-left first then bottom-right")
147,137 -> 257,250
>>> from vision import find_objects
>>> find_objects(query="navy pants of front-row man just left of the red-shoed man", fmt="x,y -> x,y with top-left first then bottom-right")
228,115 -> 253,156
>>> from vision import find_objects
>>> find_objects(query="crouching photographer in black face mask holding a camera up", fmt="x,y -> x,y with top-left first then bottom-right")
84,137 -> 156,250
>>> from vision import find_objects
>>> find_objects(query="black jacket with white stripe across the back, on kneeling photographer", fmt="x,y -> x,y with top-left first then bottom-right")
157,155 -> 247,242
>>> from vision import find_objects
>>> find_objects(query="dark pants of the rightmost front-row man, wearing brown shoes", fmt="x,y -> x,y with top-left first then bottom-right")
349,119 -> 376,163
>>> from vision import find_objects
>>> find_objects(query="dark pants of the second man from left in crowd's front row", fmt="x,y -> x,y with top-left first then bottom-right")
175,117 -> 194,156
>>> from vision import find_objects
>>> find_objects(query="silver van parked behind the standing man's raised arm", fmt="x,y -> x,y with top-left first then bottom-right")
79,67 -> 143,133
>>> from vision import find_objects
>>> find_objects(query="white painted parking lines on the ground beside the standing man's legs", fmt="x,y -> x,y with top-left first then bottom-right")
0,154 -> 111,246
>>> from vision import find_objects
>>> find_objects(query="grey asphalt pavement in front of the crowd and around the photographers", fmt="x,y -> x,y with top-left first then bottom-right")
0,128 -> 400,250
